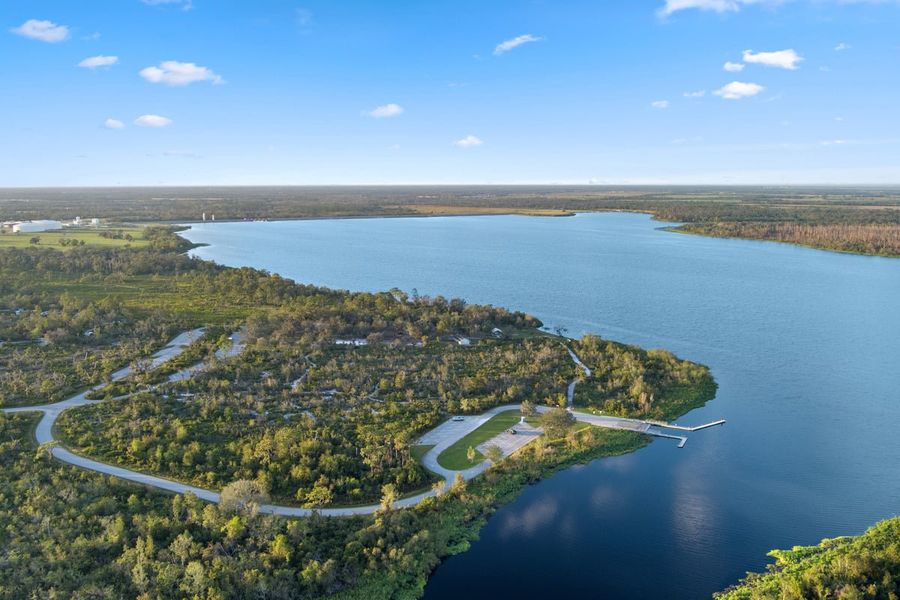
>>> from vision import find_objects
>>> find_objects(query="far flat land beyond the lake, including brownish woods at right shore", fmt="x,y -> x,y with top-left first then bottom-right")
0,185 -> 900,256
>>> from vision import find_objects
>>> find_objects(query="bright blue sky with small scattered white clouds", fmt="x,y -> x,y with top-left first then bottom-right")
0,0 -> 900,186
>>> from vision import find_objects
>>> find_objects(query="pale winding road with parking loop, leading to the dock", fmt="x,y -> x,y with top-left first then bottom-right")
3,329 -> 724,517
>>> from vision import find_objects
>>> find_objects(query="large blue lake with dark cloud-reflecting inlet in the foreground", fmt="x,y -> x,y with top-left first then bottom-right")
186,214 -> 900,599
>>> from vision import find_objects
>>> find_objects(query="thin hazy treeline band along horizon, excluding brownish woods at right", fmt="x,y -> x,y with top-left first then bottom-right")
0,186 -> 900,223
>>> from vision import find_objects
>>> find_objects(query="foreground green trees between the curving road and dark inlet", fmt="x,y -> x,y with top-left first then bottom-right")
0,384 -> 646,600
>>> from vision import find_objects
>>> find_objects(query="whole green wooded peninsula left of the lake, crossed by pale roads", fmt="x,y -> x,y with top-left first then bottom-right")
0,232 -> 712,599
